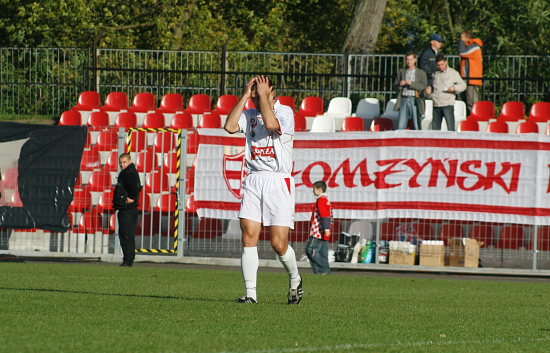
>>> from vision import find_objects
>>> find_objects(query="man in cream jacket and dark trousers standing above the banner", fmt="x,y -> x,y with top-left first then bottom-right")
426,54 -> 466,131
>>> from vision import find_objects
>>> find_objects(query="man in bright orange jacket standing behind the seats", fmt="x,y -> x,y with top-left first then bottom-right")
458,30 -> 483,113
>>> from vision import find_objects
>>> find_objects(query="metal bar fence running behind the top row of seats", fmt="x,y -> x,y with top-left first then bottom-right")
0,48 -> 550,116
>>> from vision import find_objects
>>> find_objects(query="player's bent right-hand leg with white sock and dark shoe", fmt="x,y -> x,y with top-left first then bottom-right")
271,226 -> 303,304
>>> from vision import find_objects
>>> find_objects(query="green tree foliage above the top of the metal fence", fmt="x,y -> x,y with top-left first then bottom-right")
0,0 -> 550,55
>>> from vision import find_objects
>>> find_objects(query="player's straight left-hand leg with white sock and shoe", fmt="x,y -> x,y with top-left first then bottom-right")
237,218 -> 262,303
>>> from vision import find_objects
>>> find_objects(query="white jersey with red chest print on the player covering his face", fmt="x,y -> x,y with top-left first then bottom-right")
239,101 -> 294,175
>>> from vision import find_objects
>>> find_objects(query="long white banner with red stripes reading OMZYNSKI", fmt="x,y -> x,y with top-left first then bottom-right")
194,129 -> 550,225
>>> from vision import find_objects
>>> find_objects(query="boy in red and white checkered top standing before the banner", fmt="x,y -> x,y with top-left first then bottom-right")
306,181 -> 332,274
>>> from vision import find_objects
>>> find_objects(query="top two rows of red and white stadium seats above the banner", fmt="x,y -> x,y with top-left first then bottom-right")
60,91 -> 550,133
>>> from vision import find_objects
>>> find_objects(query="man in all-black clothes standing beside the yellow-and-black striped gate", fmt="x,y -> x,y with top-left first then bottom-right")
113,153 -> 141,267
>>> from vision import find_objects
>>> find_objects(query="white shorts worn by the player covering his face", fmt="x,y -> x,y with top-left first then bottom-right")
239,172 -> 294,229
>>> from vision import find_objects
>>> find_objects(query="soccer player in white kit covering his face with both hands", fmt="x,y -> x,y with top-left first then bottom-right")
224,76 -> 303,304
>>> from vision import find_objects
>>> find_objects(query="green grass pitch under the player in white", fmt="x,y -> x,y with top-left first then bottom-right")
0,263 -> 550,353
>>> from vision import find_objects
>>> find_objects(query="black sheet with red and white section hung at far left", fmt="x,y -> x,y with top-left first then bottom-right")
0,122 -> 87,232
